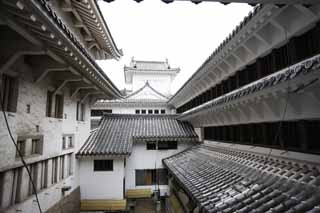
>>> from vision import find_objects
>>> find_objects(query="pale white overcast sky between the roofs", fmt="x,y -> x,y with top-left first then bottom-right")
98,0 -> 252,93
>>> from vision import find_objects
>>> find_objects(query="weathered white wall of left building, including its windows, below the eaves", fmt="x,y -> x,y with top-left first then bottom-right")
0,57 -> 90,213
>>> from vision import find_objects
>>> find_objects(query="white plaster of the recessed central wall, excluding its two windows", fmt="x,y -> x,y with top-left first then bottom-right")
125,142 -> 192,196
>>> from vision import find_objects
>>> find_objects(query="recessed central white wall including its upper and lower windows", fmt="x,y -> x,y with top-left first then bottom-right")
125,140 -> 192,196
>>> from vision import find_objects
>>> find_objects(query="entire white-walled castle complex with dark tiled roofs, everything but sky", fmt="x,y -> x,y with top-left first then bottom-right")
0,0 -> 320,213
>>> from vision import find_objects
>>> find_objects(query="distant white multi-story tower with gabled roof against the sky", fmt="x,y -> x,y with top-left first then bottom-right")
91,58 -> 180,128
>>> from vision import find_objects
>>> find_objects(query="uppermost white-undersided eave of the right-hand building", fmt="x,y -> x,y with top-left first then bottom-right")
168,4 -> 320,108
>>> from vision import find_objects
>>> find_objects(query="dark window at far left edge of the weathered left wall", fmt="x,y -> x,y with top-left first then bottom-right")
0,74 -> 18,112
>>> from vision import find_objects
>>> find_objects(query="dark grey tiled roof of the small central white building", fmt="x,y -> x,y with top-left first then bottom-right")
78,114 -> 197,155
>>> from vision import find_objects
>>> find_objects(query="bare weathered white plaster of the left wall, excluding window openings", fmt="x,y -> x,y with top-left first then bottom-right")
0,59 -> 90,213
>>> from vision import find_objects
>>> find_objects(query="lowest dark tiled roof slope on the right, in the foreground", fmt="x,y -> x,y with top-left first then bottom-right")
163,145 -> 320,213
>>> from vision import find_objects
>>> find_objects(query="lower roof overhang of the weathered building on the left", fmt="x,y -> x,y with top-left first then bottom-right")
0,0 -> 121,99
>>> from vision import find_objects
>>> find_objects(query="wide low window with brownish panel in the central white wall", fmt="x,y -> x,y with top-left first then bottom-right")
136,169 -> 168,186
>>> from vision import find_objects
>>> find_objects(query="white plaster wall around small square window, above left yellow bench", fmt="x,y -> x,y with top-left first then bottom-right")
79,158 -> 124,199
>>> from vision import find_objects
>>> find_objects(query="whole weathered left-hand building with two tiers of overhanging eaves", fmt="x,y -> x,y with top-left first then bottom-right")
0,0 -> 122,213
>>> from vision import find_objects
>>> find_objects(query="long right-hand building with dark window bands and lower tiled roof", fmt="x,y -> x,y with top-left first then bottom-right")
164,4 -> 320,212
